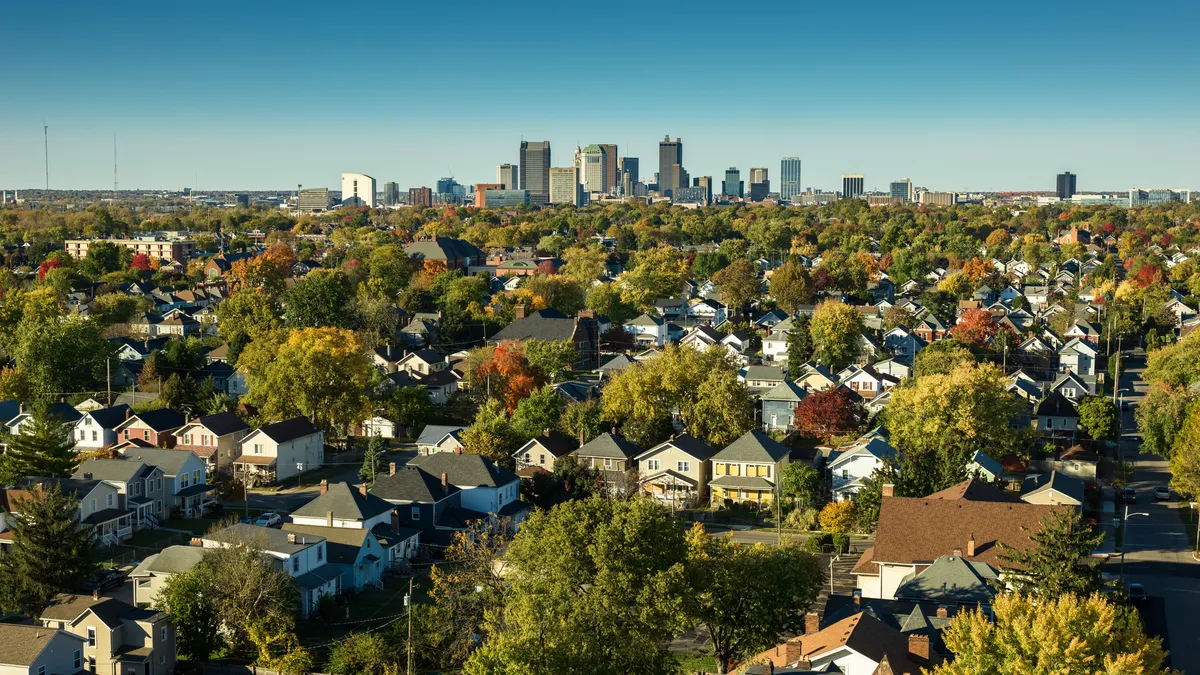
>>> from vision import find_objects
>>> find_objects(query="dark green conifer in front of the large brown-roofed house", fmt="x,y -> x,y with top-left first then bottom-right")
1000,507 -> 1104,598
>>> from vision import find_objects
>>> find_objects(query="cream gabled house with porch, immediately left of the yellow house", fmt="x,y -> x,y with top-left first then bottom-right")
637,434 -> 716,506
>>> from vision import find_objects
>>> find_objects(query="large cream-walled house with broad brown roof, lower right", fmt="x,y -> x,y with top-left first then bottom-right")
852,479 -> 1056,599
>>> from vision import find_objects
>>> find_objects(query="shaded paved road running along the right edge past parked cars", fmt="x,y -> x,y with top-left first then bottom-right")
1108,350 -> 1200,674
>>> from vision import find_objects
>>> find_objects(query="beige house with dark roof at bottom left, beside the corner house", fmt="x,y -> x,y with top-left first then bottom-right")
38,595 -> 175,675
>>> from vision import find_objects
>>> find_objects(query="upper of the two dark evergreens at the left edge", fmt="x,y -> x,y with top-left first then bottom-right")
0,407 -> 79,485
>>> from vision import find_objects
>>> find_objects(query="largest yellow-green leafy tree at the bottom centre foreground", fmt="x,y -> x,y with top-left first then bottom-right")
463,498 -> 689,675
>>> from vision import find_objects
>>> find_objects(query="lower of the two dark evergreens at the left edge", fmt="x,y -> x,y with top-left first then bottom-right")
0,482 -> 96,617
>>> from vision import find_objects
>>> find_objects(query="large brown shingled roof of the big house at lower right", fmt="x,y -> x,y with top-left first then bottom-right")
872,497 -> 1056,566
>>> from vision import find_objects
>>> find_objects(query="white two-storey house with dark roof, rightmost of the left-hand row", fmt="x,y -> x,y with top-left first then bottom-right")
233,417 -> 325,483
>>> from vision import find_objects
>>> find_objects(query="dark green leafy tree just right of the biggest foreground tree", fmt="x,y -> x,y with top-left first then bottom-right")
688,522 -> 824,673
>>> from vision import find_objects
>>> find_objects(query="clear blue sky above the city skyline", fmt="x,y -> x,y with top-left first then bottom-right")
0,0 -> 1200,191
